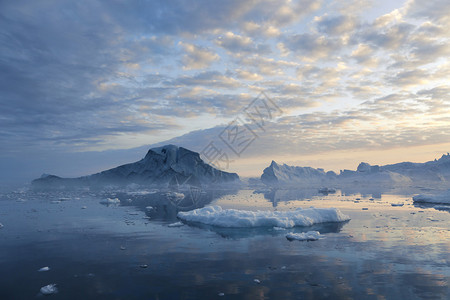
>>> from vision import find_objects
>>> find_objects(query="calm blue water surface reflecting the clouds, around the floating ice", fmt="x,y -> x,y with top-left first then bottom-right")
0,189 -> 450,299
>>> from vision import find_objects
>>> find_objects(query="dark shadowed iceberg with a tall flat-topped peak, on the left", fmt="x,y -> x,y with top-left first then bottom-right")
32,145 -> 239,188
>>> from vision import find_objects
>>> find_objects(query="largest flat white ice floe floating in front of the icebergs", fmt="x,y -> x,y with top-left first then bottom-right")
178,206 -> 350,228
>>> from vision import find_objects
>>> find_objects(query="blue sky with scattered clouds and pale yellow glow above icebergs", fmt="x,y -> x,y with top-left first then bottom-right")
0,0 -> 450,184
